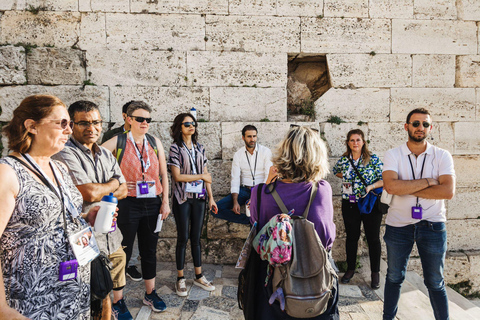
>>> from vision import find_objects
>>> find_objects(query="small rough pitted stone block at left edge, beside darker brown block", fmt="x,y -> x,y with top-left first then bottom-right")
0,46 -> 27,85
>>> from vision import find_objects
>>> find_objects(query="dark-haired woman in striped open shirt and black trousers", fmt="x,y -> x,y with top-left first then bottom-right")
168,113 -> 217,297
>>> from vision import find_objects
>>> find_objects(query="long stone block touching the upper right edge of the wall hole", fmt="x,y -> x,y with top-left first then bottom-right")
327,54 -> 412,88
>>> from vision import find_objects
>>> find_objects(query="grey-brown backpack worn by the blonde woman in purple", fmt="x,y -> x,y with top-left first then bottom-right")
269,183 -> 337,318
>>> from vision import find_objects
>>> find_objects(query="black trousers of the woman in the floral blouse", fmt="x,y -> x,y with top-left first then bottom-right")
342,200 -> 382,272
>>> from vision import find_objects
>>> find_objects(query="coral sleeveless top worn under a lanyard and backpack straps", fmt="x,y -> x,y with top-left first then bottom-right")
120,139 -> 163,197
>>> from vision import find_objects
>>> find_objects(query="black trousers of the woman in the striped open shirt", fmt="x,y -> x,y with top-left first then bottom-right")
173,197 -> 205,270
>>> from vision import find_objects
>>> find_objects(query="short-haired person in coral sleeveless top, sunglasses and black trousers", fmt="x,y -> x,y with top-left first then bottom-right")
102,101 -> 170,312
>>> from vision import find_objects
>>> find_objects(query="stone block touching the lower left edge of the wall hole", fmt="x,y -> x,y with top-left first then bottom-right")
210,87 -> 287,121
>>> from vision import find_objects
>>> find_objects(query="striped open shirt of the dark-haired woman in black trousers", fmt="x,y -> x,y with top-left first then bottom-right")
168,143 -> 208,204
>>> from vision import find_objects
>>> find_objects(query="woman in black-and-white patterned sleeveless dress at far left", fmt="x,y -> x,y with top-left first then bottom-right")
0,95 -> 99,319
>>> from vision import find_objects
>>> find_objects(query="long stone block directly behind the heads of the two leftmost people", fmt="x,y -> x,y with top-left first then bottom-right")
0,86 -> 110,121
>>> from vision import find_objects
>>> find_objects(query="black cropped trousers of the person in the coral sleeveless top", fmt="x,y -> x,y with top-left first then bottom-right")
118,197 -> 162,280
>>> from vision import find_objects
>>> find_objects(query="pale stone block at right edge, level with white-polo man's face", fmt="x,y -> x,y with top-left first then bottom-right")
455,122 -> 480,154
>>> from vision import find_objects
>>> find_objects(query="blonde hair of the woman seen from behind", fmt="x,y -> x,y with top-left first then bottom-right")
273,127 -> 329,182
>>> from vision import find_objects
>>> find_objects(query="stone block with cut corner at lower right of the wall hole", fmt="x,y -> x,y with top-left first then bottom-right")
315,88 -> 390,122
